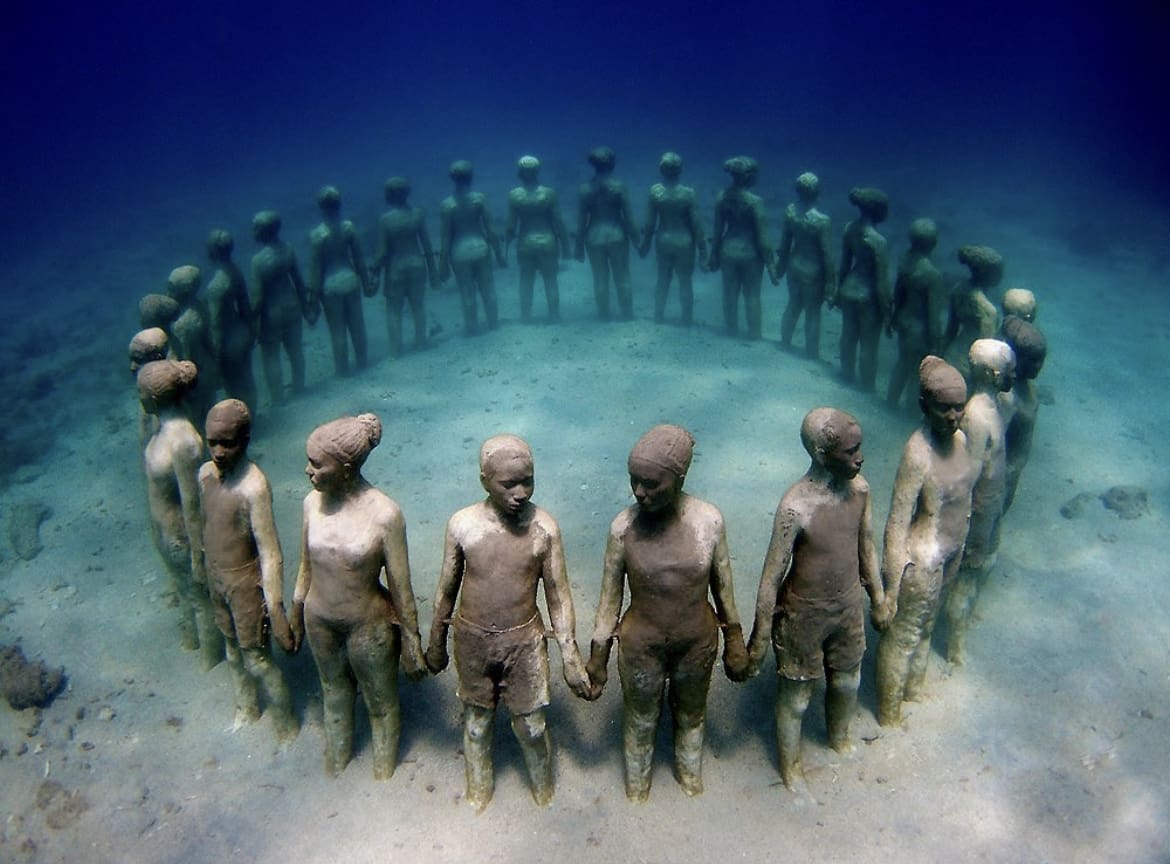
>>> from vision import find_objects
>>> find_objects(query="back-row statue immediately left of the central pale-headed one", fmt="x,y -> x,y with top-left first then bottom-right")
439,159 -> 505,336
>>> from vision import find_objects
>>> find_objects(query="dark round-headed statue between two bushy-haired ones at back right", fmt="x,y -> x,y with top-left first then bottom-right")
886,219 -> 950,407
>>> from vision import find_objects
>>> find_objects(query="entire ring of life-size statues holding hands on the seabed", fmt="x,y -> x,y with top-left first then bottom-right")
130,148 -> 1047,809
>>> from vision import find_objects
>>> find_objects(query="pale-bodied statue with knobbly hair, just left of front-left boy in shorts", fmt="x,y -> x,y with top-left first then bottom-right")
138,359 -> 223,668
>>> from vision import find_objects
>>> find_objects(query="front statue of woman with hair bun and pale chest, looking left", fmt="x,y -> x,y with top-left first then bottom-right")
290,414 -> 426,780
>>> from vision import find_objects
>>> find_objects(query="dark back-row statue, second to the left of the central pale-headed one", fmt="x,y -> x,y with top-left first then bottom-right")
373,177 -> 439,357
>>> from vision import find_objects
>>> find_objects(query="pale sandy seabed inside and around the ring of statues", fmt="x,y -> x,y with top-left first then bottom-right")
0,189 -> 1170,864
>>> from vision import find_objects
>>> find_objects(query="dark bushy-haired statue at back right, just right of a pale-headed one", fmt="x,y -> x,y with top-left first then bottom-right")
830,186 -> 890,391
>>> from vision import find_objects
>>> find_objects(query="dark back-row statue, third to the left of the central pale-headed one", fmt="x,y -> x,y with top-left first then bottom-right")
309,186 -> 374,377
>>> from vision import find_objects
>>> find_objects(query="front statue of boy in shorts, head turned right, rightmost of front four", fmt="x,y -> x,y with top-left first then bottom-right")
748,407 -> 885,790
